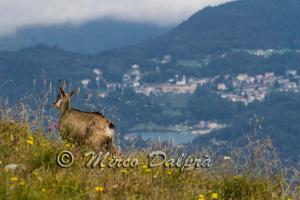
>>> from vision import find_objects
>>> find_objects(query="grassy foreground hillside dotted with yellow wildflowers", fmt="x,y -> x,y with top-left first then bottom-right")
0,120 -> 300,200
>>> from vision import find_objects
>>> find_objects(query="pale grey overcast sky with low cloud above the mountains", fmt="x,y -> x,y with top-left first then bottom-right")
0,0 -> 230,35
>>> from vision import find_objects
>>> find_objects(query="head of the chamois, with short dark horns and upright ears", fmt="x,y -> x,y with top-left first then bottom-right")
53,87 -> 74,112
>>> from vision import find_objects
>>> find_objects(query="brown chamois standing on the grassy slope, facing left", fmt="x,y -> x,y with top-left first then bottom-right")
53,87 -> 116,153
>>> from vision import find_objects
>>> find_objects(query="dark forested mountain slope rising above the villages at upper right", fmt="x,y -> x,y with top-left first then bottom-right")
121,0 -> 300,57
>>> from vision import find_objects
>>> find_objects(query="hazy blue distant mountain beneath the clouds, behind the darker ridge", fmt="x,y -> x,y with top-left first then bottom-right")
0,19 -> 172,53
